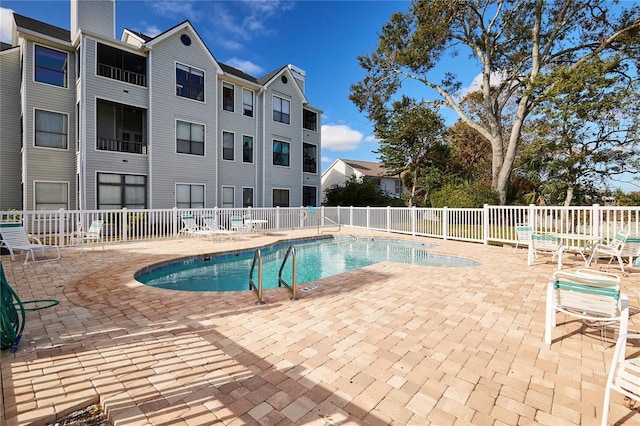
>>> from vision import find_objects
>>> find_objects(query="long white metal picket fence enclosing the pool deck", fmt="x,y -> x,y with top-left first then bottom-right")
0,205 -> 640,246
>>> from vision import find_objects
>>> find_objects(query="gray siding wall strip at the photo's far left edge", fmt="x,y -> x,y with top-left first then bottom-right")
0,49 -> 22,210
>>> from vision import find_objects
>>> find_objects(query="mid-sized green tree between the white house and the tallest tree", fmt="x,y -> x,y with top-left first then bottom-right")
376,97 -> 448,206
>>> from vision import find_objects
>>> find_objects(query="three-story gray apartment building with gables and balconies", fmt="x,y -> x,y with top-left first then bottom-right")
0,0 -> 321,210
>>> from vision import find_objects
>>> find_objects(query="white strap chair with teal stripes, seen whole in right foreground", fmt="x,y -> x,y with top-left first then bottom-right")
544,269 -> 629,345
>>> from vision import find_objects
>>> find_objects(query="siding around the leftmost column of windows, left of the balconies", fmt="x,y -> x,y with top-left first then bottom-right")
23,42 -> 76,210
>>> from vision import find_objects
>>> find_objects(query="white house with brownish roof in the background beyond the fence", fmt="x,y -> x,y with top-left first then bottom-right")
321,158 -> 404,198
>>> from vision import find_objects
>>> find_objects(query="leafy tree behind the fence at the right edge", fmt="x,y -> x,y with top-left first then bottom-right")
521,57 -> 640,206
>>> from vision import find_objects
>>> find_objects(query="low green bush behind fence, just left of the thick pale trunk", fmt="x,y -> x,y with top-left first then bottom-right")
431,182 -> 498,208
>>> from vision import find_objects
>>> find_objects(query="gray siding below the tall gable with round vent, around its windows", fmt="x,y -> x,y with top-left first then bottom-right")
149,26 -> 219,208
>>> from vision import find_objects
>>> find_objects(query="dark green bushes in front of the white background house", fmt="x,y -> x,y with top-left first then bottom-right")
323,175 -> 404,207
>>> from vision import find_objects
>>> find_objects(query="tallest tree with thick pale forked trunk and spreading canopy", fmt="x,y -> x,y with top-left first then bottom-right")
350,0 -> 640,204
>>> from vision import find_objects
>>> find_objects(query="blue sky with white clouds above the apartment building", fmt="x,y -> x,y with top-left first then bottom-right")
0,0 -> 484,175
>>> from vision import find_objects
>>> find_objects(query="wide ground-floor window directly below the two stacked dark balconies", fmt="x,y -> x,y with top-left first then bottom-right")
98,173 -> 147,210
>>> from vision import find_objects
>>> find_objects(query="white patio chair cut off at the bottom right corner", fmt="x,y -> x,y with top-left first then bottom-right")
602,334 -> 640,426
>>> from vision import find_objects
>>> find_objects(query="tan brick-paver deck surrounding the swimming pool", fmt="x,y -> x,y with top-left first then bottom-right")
0,229 -> 640,426
